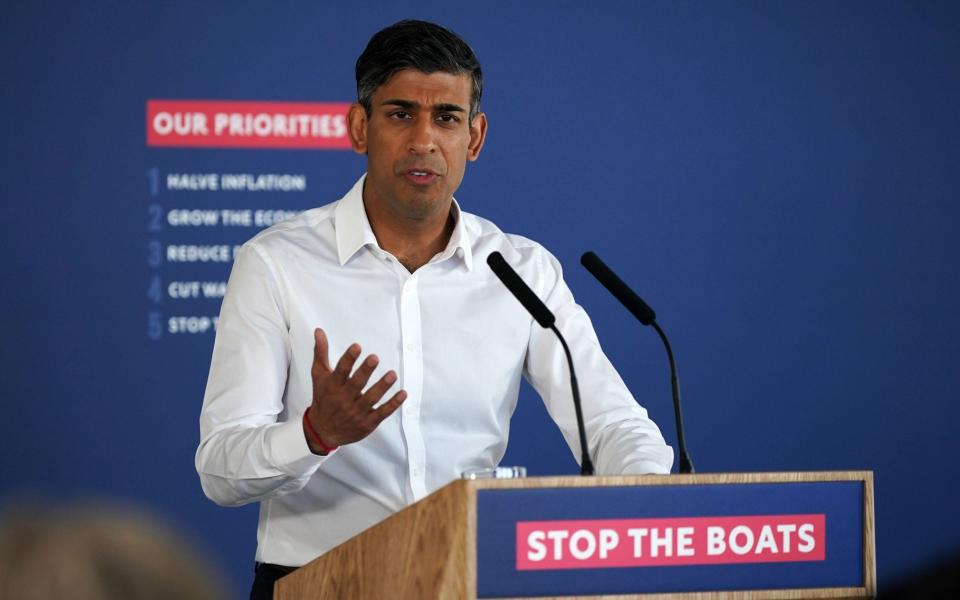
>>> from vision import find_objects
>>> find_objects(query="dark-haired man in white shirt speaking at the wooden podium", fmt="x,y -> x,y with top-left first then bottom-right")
197,21 -> 673,593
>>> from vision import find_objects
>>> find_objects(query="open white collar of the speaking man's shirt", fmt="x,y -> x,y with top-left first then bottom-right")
334,174 -> 473,271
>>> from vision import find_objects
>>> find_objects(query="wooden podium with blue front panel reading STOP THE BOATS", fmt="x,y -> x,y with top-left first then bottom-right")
276,471 -> 876,600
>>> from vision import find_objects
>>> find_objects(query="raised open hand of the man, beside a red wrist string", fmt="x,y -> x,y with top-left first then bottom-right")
304,328 -> 407,454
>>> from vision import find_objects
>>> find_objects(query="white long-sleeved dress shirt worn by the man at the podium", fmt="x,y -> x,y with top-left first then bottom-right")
196,178 -> 673,566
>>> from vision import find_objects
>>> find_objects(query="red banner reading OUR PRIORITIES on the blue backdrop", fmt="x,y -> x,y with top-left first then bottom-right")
147,100 -> 350,149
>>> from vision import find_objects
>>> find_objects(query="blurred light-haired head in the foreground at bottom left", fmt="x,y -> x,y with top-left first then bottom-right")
0,506 -> 224,600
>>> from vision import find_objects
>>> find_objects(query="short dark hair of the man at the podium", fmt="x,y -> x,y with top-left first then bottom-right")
356,21 -> 483,121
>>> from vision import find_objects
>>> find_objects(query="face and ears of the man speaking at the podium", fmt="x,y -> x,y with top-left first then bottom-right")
350,69 -> 487,220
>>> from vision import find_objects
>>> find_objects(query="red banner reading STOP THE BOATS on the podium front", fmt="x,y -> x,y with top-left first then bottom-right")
517,514 -> 826,571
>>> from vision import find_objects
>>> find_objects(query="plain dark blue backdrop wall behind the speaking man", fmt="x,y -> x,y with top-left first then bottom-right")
0,0 -> 960,590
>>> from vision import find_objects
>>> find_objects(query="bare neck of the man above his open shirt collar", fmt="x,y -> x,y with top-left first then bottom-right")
364,196 -> 456,273
